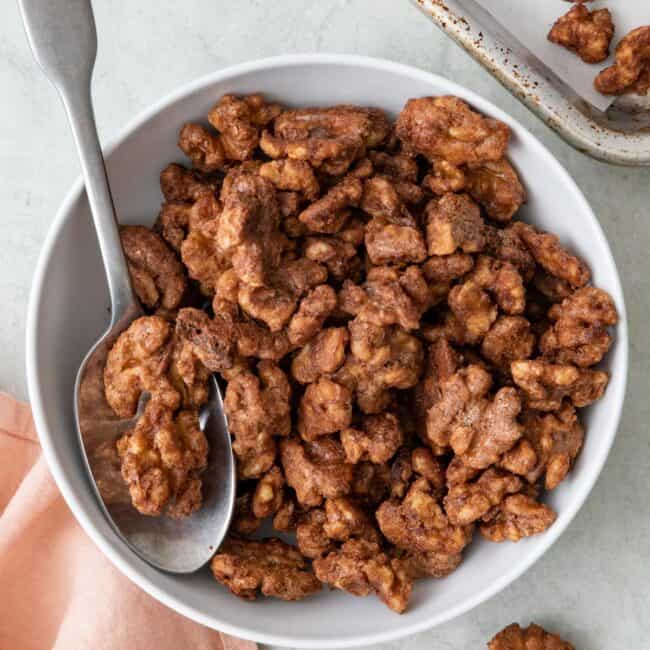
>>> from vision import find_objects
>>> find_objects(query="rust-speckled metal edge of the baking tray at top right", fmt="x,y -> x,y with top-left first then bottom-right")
410,0 -> 650,166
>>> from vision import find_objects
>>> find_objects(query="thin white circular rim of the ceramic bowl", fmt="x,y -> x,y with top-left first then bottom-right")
25,53 -> 629,648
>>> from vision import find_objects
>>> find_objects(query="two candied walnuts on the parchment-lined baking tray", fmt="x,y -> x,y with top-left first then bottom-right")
548,0 -> 650,95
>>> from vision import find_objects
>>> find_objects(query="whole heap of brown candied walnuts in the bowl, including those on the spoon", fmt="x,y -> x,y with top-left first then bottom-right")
105,95 -> 617,612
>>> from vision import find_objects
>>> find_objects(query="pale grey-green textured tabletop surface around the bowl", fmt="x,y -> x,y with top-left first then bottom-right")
0,0 -> 650,650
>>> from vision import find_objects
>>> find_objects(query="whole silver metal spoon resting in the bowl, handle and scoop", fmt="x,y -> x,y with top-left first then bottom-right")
19,0 -> 235,573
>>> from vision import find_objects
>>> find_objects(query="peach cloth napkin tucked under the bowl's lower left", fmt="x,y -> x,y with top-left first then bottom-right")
0,393 -> 256,650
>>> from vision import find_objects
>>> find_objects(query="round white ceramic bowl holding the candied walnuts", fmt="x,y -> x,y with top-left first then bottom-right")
27,55 -> 628,648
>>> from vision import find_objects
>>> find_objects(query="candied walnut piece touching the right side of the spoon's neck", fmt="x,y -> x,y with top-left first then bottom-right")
120,226 -> 187,309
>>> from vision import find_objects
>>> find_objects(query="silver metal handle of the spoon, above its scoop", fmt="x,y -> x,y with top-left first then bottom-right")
19,0 -> 140,326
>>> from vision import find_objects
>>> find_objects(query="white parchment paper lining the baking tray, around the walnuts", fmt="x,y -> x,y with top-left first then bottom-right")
475,0 -> 650,111
